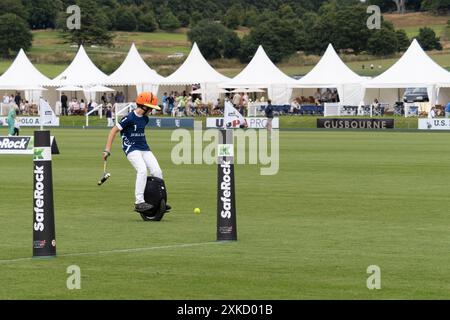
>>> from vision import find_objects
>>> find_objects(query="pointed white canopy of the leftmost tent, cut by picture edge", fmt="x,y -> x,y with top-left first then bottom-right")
0,49 -> 50,90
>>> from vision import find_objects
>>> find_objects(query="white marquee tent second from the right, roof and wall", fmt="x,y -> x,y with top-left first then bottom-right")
293,43 -> 364,105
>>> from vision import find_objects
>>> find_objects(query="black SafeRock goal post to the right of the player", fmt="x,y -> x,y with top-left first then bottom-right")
217,130 -> 237,241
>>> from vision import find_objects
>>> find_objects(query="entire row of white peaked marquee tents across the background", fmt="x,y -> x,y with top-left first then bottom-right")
0,40 -> 450,110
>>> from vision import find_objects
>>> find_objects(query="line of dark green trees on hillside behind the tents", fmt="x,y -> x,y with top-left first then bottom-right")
0,0 -> 450,62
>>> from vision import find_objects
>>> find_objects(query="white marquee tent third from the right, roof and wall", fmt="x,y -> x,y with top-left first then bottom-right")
220,46 -> 296,104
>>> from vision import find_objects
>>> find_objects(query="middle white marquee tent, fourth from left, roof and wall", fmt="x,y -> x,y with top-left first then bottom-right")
159,43 -> 230,102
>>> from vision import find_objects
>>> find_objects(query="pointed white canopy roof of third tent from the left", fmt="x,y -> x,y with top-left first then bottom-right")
105,43 -> 164,86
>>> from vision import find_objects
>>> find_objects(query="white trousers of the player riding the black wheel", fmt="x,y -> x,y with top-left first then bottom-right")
127,150 -> 163,204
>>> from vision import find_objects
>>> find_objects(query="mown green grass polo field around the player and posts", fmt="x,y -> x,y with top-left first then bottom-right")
0,128 -> 450,299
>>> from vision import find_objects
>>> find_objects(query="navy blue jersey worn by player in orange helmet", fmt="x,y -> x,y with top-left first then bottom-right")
117,111 -> 150,155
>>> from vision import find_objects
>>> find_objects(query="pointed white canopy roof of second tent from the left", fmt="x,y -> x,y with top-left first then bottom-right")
46,46 -> 108,87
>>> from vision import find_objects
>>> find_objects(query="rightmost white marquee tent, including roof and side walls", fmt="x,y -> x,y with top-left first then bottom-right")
364,39 -> 450,105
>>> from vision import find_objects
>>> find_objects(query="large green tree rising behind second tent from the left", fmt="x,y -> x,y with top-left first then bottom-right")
61,0 -> 113,46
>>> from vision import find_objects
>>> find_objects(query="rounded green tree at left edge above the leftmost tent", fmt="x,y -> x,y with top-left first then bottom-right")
0,13 -> 33,57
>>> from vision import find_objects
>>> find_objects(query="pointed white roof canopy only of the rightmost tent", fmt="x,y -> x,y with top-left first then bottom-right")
364,39 -> 450,88
